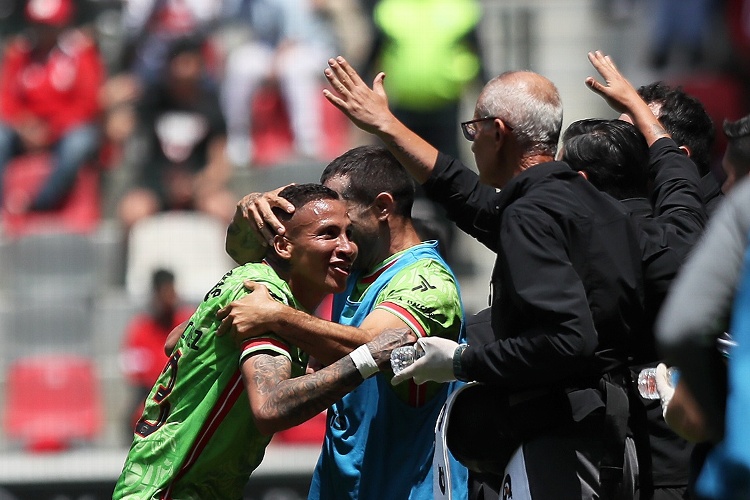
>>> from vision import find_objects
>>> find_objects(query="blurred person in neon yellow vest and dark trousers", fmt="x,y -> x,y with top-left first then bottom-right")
368,0 -> 489,272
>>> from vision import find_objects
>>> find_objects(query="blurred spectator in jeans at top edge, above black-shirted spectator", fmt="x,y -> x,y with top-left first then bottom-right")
122,0 -> 222,85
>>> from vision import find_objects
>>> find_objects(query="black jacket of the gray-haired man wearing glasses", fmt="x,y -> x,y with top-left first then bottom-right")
424,154 -> 643,394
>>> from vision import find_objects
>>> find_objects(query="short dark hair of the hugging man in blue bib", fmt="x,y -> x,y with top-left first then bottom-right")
320,146 -> 416,217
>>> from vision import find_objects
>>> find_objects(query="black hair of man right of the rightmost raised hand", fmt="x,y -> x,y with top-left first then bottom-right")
638,82 -> 716,176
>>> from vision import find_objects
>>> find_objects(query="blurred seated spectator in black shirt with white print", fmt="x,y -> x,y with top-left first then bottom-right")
118,38 -> 234,228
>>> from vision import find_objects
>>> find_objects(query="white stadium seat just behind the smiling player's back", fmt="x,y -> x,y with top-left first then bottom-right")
125,212 -> 235,305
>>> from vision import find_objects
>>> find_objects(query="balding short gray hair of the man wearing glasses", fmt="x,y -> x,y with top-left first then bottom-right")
477,71 -> 563,156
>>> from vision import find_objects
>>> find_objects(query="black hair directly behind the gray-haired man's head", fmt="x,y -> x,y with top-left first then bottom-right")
562,119 -> 649,200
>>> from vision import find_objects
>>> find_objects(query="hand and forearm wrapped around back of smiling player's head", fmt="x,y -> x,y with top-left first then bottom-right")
225,186 -> 294,265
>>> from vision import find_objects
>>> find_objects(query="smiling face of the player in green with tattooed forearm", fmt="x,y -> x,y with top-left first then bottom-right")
286,200 -> 357,295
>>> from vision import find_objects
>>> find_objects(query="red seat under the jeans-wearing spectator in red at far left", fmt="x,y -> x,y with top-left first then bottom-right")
0,153 -> 101,236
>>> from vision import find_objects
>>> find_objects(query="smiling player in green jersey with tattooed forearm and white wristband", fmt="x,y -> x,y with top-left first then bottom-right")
113,184 -> 415,499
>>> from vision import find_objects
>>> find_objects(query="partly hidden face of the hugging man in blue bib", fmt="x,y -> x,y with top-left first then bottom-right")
325,176 -> 379,270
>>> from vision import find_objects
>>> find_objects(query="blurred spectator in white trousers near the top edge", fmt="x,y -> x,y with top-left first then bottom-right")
222,0 -> 336,165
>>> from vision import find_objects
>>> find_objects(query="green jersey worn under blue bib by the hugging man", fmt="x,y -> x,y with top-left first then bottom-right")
352,248 -> 463,406
